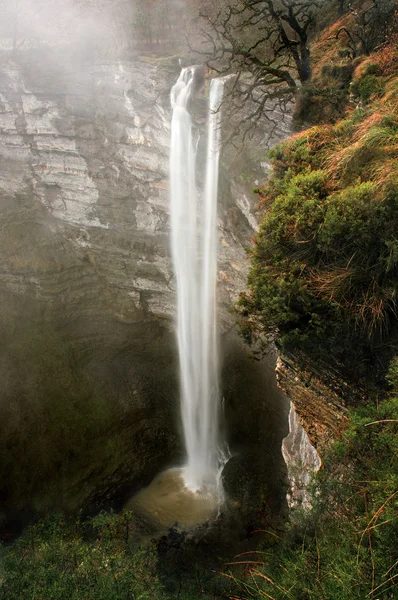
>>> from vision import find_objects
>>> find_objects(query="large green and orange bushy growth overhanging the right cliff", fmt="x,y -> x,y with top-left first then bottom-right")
238,29 -> 398,380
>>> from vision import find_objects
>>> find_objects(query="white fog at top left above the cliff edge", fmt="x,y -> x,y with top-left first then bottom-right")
0,0 -> 193,59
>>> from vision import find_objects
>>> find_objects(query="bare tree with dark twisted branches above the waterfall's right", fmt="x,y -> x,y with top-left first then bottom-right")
190,0 -> 331,138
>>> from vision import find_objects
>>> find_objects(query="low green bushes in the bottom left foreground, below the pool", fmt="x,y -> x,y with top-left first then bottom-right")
0,512 -> 227,600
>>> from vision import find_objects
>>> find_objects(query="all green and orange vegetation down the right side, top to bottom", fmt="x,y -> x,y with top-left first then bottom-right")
227,12 -> 398,600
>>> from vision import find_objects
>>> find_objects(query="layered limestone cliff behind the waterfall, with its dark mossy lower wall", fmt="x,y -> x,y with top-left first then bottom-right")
0,48 -> 270,512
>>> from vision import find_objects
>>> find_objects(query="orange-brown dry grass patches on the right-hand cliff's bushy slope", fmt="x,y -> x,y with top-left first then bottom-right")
292,44 -> 398,335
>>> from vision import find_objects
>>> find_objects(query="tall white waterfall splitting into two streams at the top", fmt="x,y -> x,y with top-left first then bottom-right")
170,67 -> 223,491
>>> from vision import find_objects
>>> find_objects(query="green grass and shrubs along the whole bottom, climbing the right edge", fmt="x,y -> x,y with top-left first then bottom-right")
0,390 -> 398,600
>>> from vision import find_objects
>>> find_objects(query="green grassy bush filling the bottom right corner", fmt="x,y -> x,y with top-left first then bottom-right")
226,382 -> 398,600
